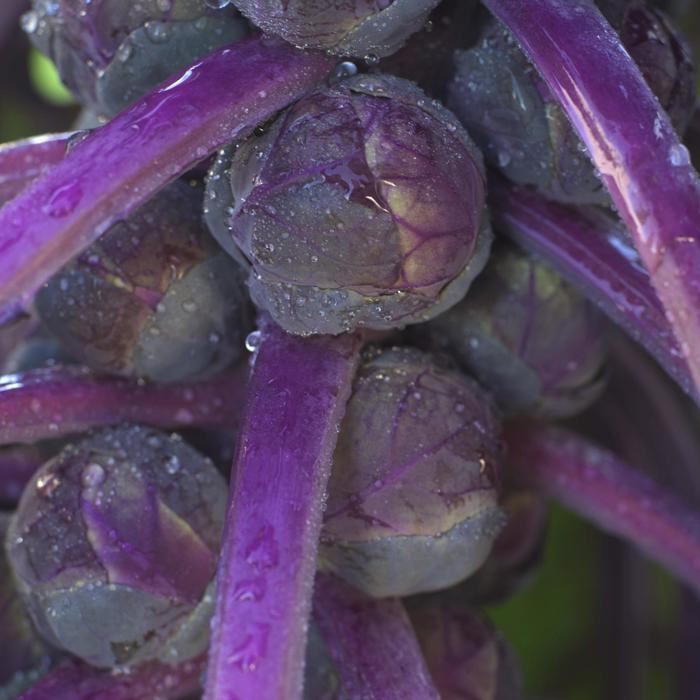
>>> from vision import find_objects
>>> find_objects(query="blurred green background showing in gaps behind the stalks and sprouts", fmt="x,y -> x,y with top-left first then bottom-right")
0,0 -> 700,700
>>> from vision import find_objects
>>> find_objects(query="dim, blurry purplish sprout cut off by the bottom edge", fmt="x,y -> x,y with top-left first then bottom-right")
406,595 -> 522,700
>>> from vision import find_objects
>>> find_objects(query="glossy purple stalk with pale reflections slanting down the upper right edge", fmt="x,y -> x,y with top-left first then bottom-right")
485,0 -> 700,400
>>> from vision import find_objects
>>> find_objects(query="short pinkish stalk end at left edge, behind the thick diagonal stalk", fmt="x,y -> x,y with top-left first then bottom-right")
0,133 -> 71,205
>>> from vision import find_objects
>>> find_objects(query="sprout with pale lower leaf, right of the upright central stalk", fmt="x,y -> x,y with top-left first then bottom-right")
319,348 -> 503,597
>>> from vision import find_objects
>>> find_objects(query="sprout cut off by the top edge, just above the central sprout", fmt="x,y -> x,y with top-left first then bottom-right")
234,0 -> 439,57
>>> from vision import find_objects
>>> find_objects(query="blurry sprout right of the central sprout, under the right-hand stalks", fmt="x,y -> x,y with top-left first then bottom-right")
428,242 -> 605,418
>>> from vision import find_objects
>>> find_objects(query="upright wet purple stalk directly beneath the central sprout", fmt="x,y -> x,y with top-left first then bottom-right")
205,325 -> 360,700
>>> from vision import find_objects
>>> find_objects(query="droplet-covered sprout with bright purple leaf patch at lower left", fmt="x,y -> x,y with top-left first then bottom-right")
6,426 -> 227,667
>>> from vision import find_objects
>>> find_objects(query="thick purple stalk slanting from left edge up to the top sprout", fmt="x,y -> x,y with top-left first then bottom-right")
0,38 -> 334,321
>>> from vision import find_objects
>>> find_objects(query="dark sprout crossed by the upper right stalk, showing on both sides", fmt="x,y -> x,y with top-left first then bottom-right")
447,0 -> 695,205
